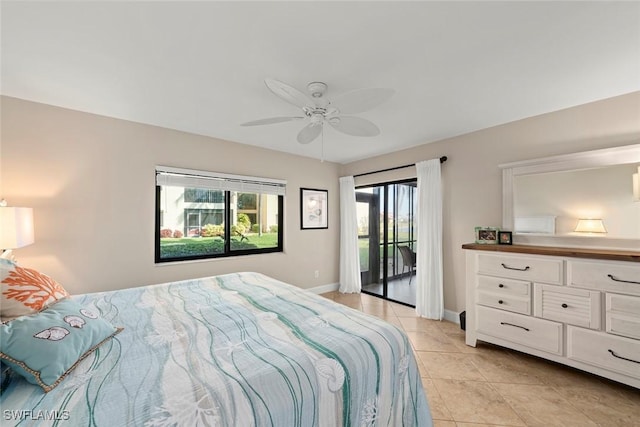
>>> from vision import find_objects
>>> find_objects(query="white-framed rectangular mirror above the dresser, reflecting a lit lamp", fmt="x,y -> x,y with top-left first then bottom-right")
500,144 -> 640,249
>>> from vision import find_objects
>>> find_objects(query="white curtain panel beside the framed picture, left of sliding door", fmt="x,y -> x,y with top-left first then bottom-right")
339,176 -> 362,293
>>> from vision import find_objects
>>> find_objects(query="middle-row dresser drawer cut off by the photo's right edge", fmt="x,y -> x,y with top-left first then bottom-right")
605,292 -> 640,339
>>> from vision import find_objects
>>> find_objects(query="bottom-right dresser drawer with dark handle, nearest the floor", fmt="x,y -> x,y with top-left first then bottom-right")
567,326 -> 640,379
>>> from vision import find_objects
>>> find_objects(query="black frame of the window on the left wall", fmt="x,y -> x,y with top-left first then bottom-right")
154,167 -> 285,264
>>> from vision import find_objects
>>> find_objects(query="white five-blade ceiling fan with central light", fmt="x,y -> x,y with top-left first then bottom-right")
241,78 -> 394,144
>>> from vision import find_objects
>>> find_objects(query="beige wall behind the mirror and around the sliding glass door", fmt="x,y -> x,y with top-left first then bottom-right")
340,92 -> 640,311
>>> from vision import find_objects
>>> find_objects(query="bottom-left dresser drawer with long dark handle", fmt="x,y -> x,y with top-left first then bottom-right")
476,306 -> 563,355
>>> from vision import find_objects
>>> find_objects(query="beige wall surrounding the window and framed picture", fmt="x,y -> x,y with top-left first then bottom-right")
0,97 -> 339,294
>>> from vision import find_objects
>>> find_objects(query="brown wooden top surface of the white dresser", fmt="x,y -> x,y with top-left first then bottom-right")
462,243 -> 640,262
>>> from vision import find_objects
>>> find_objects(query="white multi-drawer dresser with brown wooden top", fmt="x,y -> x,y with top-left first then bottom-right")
462,244 -> 640,388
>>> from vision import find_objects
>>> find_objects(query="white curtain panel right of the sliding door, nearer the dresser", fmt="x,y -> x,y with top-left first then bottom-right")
416,159 -> 444,320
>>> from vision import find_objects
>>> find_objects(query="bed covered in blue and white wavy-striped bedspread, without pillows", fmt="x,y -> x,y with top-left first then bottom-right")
0,272 -> 432,427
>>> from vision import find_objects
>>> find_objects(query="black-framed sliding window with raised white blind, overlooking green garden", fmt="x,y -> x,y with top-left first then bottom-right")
155,166 -> 286,263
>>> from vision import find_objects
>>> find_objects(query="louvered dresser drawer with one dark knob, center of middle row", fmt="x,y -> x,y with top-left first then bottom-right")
534,283 -> 601,329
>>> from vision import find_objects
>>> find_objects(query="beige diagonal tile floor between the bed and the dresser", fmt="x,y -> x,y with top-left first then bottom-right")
323,292 -> 640,427
